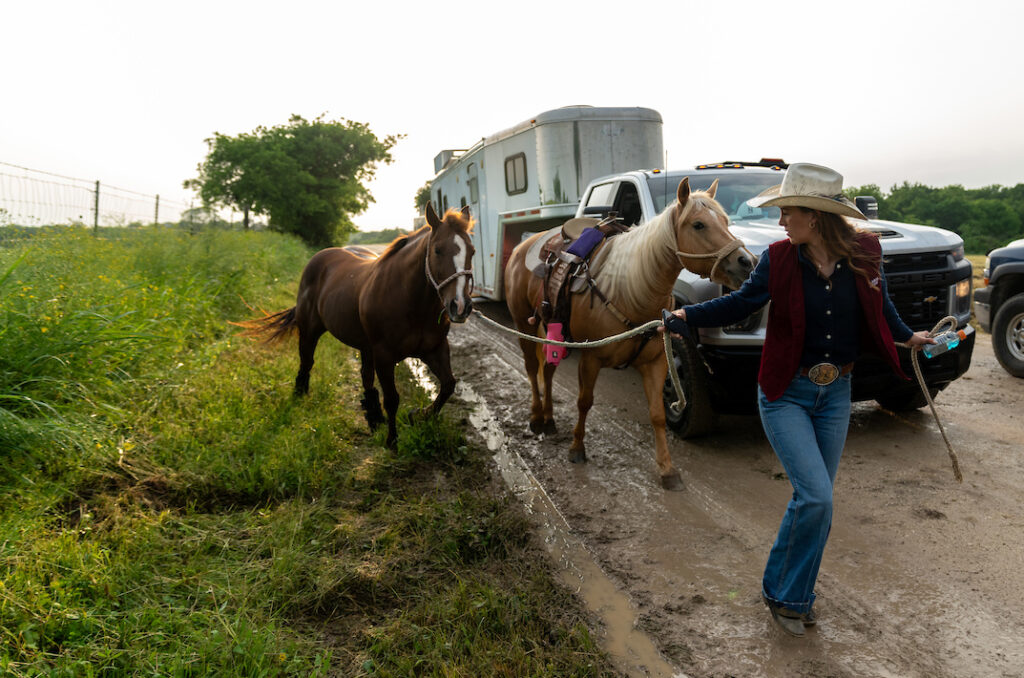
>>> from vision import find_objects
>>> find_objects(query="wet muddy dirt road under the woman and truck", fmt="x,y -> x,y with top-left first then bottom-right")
450,304 -> 1024,678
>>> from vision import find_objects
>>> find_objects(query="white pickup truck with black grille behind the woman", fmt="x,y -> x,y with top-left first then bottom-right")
575,160 -> 975,437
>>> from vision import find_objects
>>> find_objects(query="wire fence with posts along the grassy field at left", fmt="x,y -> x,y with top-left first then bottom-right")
0,161 -> 195,226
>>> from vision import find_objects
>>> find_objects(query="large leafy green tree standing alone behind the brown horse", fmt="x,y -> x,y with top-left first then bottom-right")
184,115 -> 401,247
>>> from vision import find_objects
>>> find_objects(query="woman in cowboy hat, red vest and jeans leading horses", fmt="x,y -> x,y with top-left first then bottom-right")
667,163 -> 935,636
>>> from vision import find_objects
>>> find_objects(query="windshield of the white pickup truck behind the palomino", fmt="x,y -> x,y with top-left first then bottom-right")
647,170 -> 782,221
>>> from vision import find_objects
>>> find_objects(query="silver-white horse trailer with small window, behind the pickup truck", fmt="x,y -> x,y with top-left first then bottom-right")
430,105 -> 664,299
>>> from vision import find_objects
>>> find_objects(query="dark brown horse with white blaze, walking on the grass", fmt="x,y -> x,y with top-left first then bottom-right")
242,203 -> 474,448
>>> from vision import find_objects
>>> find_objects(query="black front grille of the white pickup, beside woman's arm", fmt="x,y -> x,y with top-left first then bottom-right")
883,250 -> 956,331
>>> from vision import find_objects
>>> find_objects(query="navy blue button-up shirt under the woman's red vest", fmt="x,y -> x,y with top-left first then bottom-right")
685,247 -> 913,367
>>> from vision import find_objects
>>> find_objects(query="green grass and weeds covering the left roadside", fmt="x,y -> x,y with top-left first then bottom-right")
0,227 -> 611,676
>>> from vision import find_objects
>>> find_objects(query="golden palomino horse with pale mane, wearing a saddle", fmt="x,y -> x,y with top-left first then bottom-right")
505,179 -> 756,490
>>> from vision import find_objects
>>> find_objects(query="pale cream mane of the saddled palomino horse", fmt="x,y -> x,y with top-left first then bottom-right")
592,190 -> 729,308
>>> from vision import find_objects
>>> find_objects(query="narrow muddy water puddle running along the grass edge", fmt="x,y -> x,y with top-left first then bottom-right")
406,359 -> 686,678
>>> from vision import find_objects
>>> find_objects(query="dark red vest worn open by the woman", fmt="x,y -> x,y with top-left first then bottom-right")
758,234 -> 907,400
